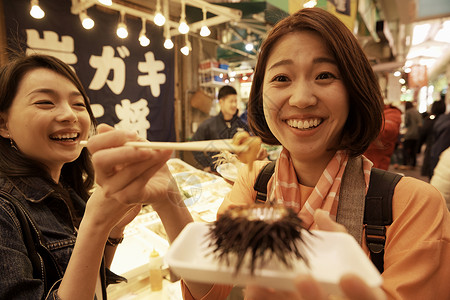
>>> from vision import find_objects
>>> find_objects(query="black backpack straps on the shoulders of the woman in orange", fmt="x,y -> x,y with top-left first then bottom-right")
253,161 -> 402,273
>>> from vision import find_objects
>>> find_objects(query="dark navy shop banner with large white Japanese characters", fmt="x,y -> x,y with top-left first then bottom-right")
3,0 -> 175,141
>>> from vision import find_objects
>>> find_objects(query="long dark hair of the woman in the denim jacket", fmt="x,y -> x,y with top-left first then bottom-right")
0,53 -> 97,201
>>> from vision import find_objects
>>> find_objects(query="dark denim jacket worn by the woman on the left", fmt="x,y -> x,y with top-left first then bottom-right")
0,177 -> 106,299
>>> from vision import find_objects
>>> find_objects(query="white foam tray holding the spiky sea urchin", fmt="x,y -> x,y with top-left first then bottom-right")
165,223 -> 382,295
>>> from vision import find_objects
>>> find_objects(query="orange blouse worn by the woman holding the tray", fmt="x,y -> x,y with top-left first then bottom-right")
182,161 -> 450,300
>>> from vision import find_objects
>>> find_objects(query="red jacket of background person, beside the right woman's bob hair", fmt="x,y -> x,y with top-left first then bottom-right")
364,104 -> 402,170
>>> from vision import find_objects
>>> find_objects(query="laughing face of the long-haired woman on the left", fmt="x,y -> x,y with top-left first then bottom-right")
0,68 -> 91,183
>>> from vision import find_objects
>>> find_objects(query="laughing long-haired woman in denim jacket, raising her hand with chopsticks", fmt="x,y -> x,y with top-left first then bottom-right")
0,55 -> 180,300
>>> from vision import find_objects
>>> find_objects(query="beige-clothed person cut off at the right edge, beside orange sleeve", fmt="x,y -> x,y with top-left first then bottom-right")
430,147 -> 450,210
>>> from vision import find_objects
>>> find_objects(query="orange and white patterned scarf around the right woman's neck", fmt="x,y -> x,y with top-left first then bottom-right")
268,148 -> 372,229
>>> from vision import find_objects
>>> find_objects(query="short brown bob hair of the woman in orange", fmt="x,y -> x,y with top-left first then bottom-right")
248,8 -> 383,156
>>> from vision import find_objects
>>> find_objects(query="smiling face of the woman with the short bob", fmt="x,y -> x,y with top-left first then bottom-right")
262,31 -> 349,186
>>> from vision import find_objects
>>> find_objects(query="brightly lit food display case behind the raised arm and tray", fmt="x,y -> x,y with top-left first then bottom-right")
107,158 -> 231,300
